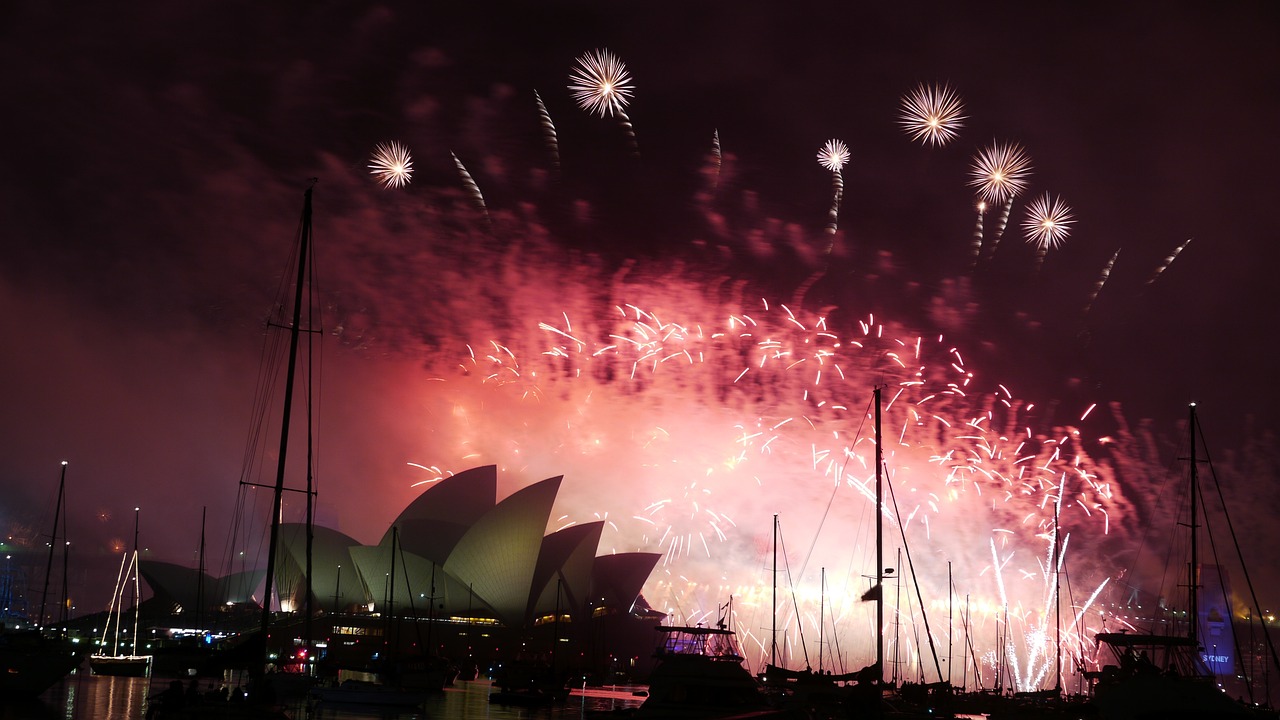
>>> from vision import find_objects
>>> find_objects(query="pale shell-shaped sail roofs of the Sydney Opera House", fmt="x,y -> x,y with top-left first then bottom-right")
142,465 -> 660,628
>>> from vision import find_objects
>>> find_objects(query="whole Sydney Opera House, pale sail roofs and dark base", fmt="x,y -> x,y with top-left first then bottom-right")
141,465 -> 660,667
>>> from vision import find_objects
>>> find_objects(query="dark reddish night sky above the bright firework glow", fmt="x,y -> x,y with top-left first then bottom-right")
0,1 -> 1280,617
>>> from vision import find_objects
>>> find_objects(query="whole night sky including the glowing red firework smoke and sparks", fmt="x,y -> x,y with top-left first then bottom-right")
0,3 -> 1280,684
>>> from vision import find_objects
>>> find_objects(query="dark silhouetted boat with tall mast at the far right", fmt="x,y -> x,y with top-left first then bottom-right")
1085,402 -> 1276,720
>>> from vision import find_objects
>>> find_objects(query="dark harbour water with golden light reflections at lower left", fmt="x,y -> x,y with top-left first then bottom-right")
0,671 -> 641,720
